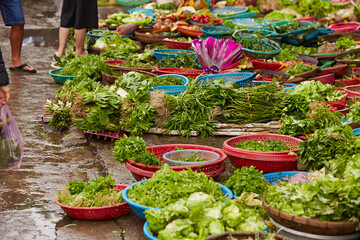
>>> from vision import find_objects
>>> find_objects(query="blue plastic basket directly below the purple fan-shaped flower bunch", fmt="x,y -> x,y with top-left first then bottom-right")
199,72 -> 255,87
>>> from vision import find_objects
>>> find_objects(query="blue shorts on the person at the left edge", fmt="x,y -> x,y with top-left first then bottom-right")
0,0 -> 25,26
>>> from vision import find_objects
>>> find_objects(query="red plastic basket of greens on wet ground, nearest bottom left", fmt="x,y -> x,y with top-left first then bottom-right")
56,184 -> 131,221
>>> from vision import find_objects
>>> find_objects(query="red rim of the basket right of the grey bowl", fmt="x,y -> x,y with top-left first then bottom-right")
223,133 -> 303,157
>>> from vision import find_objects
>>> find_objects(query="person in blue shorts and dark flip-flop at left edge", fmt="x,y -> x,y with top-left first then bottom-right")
0,0 -> 36,73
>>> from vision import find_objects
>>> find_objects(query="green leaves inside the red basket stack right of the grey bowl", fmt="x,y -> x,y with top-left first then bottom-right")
235,137 -> 298,152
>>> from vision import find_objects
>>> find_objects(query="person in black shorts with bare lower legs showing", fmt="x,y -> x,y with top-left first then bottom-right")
54,0 -> 98,58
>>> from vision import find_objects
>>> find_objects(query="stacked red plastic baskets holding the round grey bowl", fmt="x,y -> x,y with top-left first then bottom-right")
125,144 -> 227,181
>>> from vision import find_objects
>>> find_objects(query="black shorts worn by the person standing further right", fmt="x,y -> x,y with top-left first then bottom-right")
60,0 -> 98,29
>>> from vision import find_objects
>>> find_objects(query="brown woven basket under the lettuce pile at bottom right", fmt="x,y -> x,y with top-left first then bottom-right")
263,197 -> 357,236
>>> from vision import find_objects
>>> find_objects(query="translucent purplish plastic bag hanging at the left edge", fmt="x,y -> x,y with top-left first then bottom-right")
0,105 -> 24,168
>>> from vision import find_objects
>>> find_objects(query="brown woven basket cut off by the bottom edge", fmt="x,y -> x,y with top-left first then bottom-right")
205,232 -> 291,240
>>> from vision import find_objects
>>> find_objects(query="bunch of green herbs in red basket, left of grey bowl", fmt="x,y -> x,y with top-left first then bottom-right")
111,135 -> 163,166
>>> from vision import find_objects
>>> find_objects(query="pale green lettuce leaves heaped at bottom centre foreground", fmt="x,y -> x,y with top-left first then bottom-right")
145,192 -> 266,240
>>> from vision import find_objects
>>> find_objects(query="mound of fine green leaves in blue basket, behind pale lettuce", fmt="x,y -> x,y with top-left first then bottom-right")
128,164 -> 226,208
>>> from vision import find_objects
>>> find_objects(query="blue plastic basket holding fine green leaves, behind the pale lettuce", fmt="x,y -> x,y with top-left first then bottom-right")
122,179 -> 233,219
